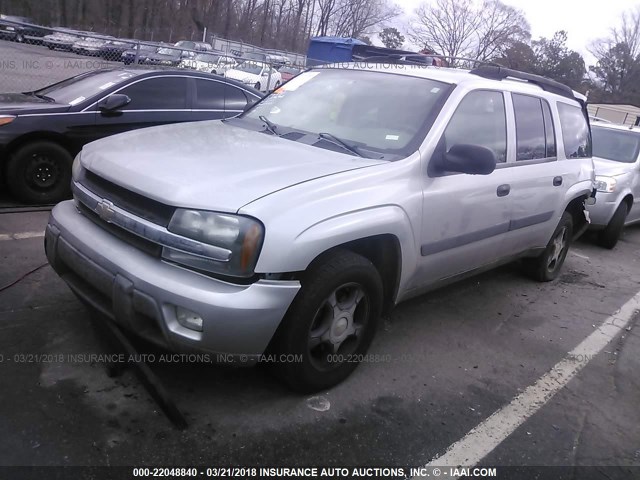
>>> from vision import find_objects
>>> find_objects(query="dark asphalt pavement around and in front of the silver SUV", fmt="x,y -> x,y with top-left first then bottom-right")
0,208 -> 640,479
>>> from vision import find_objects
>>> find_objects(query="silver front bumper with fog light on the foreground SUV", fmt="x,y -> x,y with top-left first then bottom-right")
45,201 -> 300,365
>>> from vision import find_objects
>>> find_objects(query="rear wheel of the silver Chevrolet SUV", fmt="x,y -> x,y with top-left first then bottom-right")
524,212 -> 573,282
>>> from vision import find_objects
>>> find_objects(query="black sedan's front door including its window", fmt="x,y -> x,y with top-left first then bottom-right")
96,76 -> 194,137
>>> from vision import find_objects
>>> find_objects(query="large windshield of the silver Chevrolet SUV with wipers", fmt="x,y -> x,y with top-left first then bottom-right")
242,69 -> 449,156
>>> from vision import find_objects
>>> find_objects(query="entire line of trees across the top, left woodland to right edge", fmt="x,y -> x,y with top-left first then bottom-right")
0,0 -> 640,105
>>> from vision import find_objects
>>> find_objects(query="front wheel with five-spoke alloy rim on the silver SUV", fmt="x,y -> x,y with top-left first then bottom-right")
269,250 -> 383,393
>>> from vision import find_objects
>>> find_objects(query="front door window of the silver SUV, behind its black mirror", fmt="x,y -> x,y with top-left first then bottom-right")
441,90 -> 507,163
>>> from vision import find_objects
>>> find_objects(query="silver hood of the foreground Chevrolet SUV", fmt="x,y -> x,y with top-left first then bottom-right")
81,120 -> 386,212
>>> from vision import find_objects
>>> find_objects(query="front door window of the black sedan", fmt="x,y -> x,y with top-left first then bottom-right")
119,77 -> 187,110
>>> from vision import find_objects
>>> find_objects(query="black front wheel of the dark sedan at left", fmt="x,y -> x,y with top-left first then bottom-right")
6,140 -> 73,204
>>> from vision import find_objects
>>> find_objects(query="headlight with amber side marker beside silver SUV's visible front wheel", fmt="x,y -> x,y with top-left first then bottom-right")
162,209 -> 264,278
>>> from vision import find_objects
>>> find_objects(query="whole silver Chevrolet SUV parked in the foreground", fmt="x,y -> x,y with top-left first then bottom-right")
46,64 -> 594,391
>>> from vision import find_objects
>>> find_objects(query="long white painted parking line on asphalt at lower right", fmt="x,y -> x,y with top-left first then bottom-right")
414,292 -> 640,478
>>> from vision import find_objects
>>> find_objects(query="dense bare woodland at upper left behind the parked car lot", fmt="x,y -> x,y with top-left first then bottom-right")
0,0 -> 402,52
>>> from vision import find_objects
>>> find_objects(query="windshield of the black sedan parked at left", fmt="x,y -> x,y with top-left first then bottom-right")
35,70 -> 135,105
